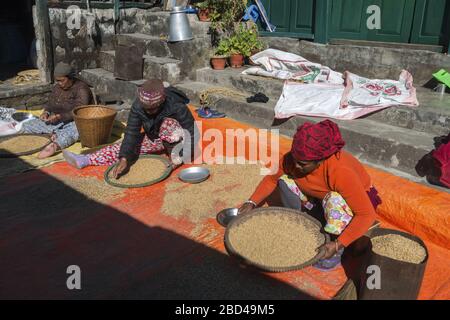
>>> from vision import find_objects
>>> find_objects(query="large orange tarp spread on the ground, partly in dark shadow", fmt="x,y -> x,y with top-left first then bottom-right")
0,105 -> 450,299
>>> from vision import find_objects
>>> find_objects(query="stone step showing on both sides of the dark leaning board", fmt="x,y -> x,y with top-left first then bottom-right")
99,50 -> 182,83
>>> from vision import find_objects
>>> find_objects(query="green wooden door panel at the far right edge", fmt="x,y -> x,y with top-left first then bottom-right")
411,0 -> 450,45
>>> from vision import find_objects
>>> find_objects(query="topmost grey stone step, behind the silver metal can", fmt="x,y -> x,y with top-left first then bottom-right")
136,11 -> 211,38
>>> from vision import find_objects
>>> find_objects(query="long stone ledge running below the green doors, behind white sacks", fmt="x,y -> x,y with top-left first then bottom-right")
263,37 -> 450,86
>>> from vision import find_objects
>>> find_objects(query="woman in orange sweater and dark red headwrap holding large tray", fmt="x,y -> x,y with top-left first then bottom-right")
239,120 -> 381,270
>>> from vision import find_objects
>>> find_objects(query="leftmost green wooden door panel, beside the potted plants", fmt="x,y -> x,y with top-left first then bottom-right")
260,0 -> 315,39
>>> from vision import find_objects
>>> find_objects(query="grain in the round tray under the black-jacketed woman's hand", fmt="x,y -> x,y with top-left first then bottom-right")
109,158 -> 167,186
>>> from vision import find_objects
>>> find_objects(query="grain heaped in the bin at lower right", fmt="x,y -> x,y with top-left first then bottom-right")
372,234 -> 427,264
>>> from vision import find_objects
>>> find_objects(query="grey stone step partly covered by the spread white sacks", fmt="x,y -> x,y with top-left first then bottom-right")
196,67 -> 450,136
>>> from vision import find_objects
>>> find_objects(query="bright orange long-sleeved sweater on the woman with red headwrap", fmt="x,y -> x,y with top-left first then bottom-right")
250,151 -> 376,247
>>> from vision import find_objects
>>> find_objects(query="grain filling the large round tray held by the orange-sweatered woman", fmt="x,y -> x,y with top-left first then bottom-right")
229,211 -> 325,268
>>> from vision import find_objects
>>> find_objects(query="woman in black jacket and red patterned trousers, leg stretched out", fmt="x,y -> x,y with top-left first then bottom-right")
63,79 -> 198,178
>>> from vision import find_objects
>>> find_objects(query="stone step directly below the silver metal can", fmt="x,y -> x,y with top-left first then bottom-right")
116,33 -> 212,79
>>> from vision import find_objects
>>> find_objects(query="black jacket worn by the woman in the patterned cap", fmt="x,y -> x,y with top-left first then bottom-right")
119,87 -> 196,163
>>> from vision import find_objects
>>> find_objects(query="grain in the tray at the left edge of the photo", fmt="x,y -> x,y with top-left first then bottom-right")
0,135 -> 50,154
